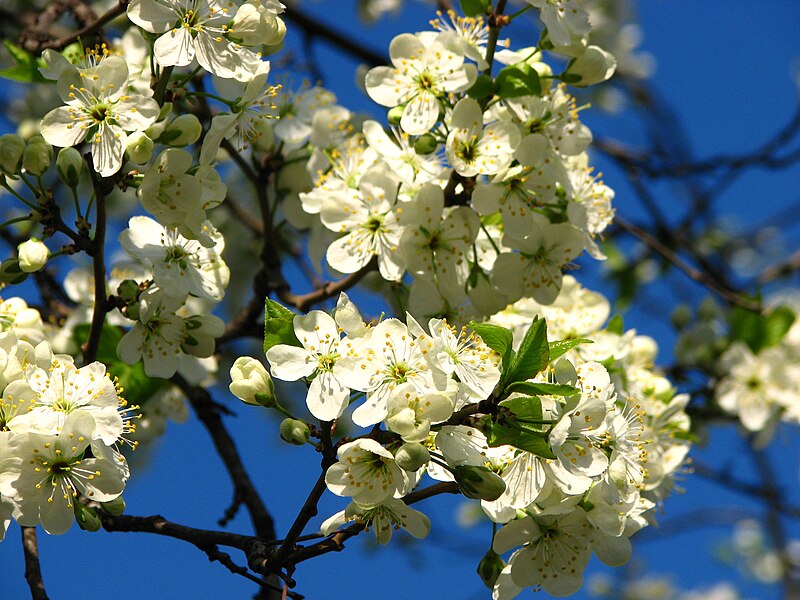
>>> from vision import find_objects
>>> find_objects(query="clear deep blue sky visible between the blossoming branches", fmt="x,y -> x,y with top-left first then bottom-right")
0,0 -> 800,600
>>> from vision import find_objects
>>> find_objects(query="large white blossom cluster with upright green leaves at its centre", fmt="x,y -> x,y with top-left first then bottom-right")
231,276 -> 689,598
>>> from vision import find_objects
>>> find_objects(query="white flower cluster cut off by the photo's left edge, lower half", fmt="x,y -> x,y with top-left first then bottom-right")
0,332 -> 131,539
